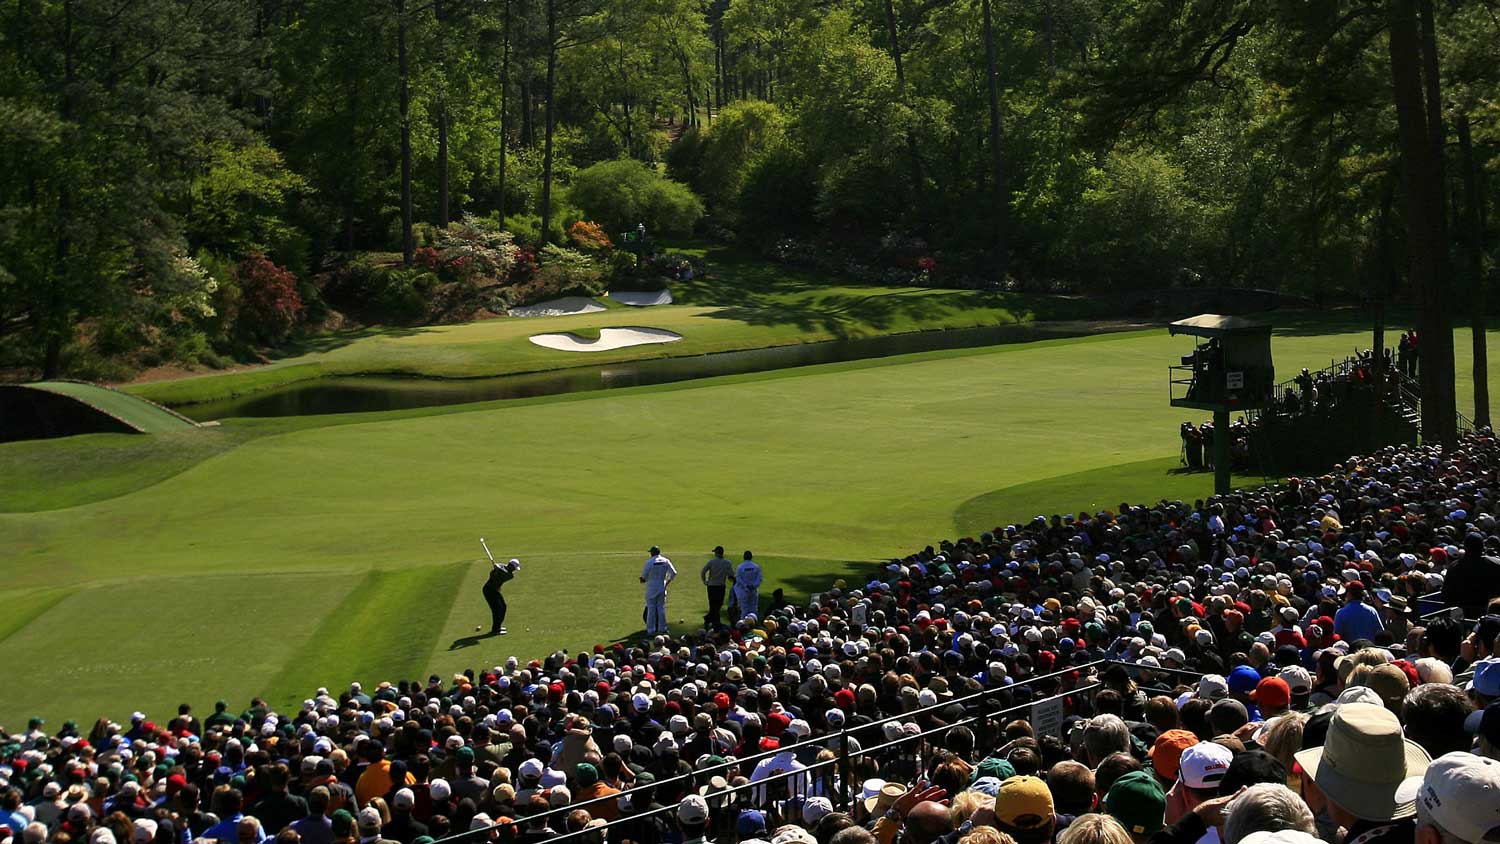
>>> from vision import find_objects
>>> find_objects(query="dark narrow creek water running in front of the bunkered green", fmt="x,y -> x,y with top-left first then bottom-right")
174,322 -> 1128,421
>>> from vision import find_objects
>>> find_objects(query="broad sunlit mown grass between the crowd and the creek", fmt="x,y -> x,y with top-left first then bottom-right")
0,324 -> 1500,724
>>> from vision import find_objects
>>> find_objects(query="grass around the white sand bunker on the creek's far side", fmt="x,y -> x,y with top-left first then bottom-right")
128,247 -> 1095,405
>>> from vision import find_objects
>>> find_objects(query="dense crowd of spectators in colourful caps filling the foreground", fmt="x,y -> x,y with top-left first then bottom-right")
0,433 -> 1500,844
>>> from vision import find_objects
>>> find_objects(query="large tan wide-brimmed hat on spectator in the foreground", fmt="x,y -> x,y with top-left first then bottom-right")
1296,703 -> 1433,820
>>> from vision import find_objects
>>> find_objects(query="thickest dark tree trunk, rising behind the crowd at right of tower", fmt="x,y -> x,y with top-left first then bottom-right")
1388,0 -> 1458,445
